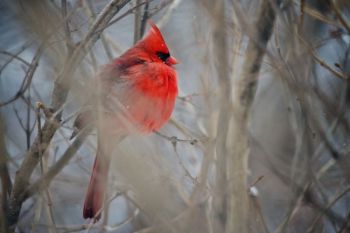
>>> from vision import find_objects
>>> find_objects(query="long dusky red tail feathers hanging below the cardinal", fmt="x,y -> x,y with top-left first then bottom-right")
83,148 -> 111,220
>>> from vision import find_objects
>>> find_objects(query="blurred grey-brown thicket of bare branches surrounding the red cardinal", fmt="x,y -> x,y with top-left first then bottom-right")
0,0 -> 350,233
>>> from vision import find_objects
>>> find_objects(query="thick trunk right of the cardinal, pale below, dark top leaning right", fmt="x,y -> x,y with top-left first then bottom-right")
226,0 -> 278,233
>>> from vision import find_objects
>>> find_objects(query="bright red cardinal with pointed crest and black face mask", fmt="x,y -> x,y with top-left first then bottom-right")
75,22 -> 177,220
